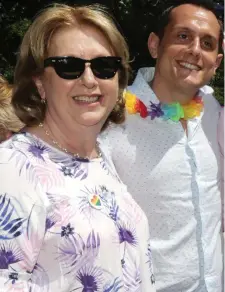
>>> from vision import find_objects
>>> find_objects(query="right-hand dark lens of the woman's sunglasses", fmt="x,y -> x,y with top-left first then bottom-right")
91,57 -> 121,79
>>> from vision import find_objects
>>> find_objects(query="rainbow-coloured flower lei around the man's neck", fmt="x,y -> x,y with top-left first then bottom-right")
124,91 -> 203,122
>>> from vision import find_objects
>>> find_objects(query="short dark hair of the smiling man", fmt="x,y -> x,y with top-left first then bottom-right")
154,0 -> 224,52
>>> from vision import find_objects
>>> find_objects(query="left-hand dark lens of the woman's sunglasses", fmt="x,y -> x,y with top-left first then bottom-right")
55,57 -> 85,79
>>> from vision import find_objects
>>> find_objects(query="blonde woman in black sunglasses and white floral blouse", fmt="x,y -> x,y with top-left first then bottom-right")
0,5 -> 155,292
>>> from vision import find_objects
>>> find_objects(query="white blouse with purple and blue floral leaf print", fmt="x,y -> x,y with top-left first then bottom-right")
0,133 -> 155,292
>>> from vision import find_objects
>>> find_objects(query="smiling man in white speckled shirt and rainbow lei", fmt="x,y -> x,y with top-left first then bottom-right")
101,0 -> 223,292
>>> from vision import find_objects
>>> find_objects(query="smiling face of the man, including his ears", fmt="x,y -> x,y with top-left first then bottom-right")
148,4 -> 222,92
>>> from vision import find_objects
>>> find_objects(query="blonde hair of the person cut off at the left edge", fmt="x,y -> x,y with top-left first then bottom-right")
0,75 -> 23,142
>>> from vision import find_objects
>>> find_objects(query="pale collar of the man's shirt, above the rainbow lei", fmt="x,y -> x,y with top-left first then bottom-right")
128,67 -> 214,106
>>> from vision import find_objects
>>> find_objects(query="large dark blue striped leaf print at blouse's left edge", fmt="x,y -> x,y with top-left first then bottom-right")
0,194 -> 26,240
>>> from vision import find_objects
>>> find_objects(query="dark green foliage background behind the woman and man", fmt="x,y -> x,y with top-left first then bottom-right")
0,0 -> 224,105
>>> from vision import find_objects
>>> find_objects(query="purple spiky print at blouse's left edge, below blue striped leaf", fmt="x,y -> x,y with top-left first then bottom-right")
0,243 -> 22,270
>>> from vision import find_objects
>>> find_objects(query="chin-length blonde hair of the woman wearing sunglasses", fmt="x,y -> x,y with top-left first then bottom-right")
12,4 -> 130,128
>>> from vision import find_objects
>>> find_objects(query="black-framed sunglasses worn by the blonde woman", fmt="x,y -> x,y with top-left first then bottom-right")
44,56 -> 122,79
